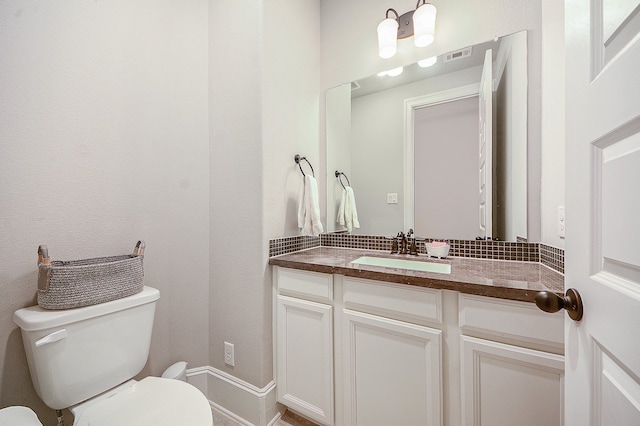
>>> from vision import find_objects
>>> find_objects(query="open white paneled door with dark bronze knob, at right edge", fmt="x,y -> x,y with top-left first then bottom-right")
565,0 -> 640,426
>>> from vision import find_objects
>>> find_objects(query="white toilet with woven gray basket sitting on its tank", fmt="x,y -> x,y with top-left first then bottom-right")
11,286 -> 213,426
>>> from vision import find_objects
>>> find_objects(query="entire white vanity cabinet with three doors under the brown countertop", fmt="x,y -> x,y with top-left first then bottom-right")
274,266 -> 564,426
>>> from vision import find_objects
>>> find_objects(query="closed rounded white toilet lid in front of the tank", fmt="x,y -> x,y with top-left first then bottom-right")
74,377 -> 213,426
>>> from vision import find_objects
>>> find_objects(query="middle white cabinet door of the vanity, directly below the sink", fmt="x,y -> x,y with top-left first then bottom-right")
343,309 -> 442,426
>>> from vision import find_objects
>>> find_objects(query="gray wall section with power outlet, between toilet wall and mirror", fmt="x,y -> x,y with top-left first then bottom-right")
208,0 -> 325,388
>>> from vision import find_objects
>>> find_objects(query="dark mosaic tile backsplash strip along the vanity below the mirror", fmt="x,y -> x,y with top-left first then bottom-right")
269,234 -> 564,274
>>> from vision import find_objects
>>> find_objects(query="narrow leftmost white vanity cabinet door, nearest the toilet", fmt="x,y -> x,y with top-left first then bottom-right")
276,295 -> 333,425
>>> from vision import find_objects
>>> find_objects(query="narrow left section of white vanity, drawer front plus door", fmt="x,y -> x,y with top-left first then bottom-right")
274,268 -> 334,425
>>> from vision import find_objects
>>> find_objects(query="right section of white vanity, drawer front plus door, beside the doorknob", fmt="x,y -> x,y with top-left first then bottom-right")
459,294 -> 564,426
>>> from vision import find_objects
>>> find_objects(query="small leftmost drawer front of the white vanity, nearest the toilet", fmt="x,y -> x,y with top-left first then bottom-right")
274,266 -> 333,303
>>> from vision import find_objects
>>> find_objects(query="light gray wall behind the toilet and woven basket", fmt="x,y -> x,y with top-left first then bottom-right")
0,0 -> 210,424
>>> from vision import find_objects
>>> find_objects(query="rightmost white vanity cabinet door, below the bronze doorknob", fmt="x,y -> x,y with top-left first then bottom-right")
461,336 -> 564,426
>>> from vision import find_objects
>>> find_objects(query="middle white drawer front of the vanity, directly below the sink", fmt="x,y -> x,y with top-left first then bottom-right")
343,277 -> 442,324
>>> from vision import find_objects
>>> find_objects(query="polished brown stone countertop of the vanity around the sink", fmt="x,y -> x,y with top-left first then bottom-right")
269,247 -> 564,302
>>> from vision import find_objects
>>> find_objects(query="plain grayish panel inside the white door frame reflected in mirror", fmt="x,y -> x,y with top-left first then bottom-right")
413,96 -> 478,239
